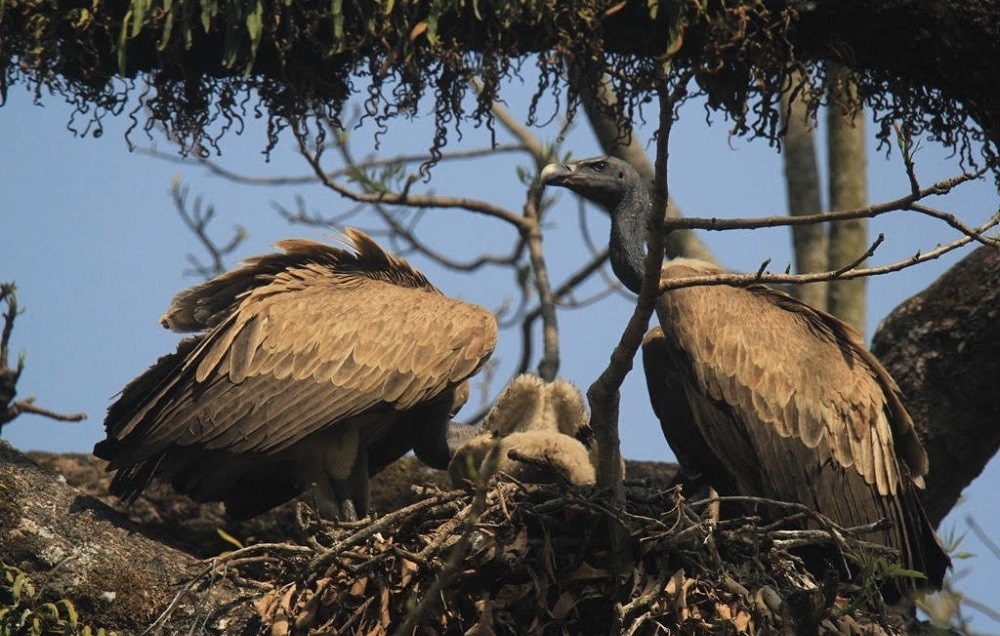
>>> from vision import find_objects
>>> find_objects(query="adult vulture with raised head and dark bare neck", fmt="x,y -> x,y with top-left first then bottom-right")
541,157 -> 950,588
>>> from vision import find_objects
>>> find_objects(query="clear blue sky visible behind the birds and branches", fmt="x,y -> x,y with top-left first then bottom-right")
0,80 -> 1000,632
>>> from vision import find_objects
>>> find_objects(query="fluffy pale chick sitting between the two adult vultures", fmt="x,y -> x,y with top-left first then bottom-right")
448,374 -> 597,488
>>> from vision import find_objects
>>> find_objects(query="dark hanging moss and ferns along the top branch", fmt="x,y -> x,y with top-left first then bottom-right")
0,0 -> 1000,173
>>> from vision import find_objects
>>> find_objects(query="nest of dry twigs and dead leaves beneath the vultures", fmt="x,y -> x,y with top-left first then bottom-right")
201,476 -> 916,635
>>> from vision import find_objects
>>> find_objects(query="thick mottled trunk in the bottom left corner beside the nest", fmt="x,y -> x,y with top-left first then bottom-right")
0,440 -> 256,634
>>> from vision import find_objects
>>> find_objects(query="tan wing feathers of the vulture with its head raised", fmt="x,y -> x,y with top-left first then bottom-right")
657,261 -> 926,495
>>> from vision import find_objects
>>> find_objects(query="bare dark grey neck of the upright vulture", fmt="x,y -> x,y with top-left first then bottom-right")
608,179 -> 652,294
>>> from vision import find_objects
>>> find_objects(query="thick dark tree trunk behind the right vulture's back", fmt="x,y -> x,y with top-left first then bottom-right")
872,246 -> 1000,525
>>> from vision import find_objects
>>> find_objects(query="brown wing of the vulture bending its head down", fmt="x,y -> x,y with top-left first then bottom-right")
95,230 -> 497,504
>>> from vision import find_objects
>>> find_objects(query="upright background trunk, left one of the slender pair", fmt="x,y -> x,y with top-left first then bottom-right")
781,74 -> 829,310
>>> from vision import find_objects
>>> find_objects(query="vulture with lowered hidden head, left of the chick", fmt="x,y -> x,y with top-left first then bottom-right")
94,229 -> 497,520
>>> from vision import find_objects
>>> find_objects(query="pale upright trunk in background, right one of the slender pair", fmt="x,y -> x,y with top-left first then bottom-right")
827,64 -> 868,335
